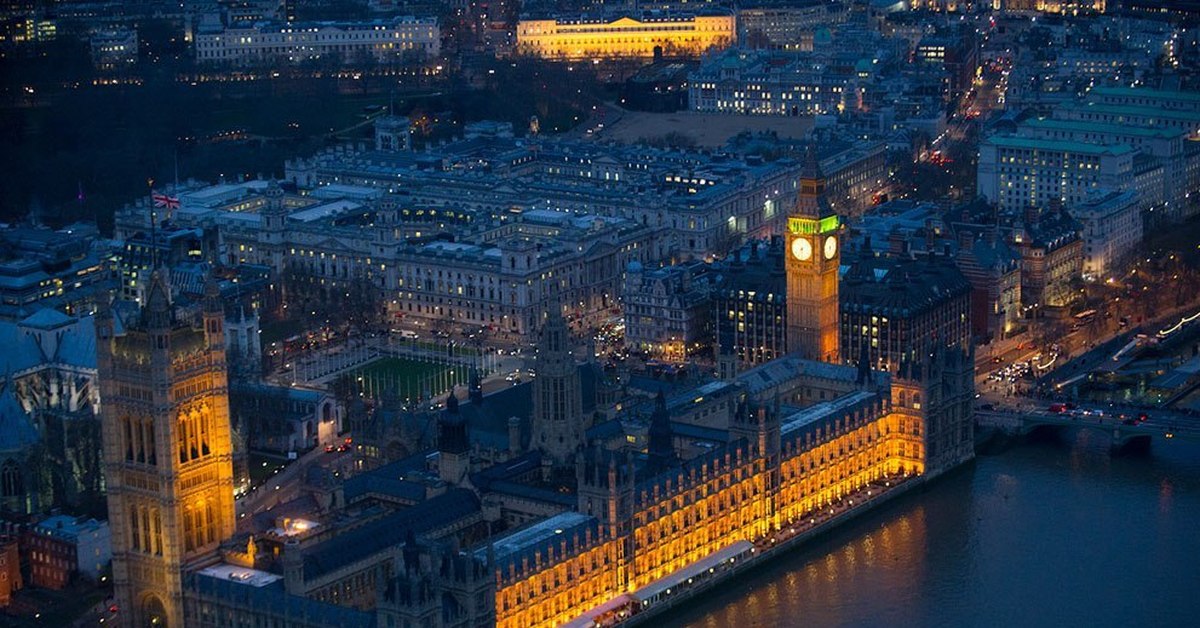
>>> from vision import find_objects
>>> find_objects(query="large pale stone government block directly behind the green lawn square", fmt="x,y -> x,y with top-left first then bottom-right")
118,183 -> 670,336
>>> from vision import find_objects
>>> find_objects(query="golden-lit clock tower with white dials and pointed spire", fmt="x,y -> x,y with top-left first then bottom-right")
784,146 -> 841,363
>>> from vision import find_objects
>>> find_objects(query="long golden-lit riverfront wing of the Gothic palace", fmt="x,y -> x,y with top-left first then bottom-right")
492,374 -> 925,628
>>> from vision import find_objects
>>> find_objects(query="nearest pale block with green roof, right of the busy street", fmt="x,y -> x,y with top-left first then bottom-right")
977,136 -> 1135,213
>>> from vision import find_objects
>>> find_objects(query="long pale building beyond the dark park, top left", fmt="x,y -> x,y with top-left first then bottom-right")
192,17 -> 442,66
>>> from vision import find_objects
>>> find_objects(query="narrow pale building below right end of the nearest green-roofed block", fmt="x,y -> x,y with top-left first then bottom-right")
1068,191 -> 1142,280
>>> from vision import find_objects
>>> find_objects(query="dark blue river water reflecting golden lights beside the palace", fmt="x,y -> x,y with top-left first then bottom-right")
662,432 -> 1200,627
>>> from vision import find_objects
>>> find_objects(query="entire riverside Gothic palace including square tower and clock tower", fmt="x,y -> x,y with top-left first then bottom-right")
96,157 -> 974,628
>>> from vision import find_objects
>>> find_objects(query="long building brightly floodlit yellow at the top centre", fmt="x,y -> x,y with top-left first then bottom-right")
517,12 -> 737,59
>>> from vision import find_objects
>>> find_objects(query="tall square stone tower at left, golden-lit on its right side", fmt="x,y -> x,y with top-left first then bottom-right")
96,270 -> 234,627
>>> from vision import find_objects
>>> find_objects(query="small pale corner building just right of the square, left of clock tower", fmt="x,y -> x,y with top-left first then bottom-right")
623,262 -> 713,361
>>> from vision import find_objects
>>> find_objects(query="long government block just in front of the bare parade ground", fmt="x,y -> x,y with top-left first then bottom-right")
282,131 -> 806,261
